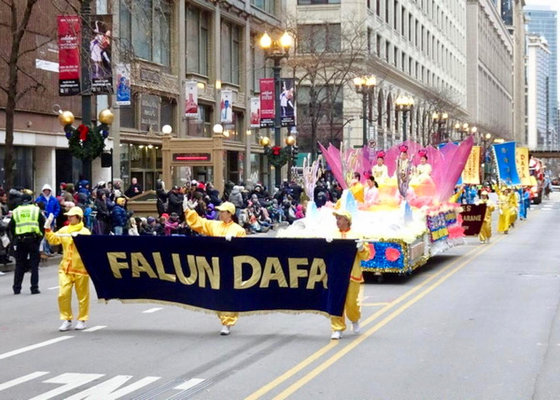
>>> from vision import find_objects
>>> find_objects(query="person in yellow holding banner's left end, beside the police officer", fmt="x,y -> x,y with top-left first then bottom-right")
45,207 -> 91,332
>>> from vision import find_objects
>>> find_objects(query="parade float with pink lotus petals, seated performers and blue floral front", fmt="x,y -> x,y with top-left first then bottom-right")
278,137 -> 473,276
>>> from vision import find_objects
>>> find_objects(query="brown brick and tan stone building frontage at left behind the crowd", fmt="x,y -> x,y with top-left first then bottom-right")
0,0 -> 284,194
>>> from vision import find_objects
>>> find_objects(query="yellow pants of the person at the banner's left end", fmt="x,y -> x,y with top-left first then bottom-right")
58,271 -> 89,321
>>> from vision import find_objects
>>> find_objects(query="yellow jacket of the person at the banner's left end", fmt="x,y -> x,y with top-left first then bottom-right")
45,223 -> 91,275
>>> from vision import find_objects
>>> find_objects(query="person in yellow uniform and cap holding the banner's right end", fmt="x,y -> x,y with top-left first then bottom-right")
327,210 -> 370,340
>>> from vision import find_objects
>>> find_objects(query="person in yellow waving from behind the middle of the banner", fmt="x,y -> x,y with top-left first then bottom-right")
183,197 -> 246,336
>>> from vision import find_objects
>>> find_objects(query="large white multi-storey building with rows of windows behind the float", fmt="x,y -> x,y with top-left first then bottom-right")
288,0 -> 467,152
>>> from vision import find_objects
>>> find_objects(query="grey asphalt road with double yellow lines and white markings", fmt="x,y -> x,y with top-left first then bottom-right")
0,193 -> 560,400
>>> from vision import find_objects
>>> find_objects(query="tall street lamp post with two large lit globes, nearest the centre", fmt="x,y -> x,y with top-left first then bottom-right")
259,32 -> 293,185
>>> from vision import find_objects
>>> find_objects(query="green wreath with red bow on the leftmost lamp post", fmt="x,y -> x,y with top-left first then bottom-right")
64,124 -> 109,161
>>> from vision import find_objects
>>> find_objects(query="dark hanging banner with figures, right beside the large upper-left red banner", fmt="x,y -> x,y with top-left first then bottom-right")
89,15 -> 113,94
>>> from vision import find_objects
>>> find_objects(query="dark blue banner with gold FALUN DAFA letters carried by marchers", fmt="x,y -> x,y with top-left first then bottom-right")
74,235 -> 357,316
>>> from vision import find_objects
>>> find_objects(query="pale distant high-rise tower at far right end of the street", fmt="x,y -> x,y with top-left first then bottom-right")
527,35 -> 551,149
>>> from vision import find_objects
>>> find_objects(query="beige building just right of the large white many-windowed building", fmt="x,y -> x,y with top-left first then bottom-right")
467,0 -> 514,140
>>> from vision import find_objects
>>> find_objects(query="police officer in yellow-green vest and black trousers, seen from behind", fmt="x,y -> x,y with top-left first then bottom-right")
8,194 -> 45,294
